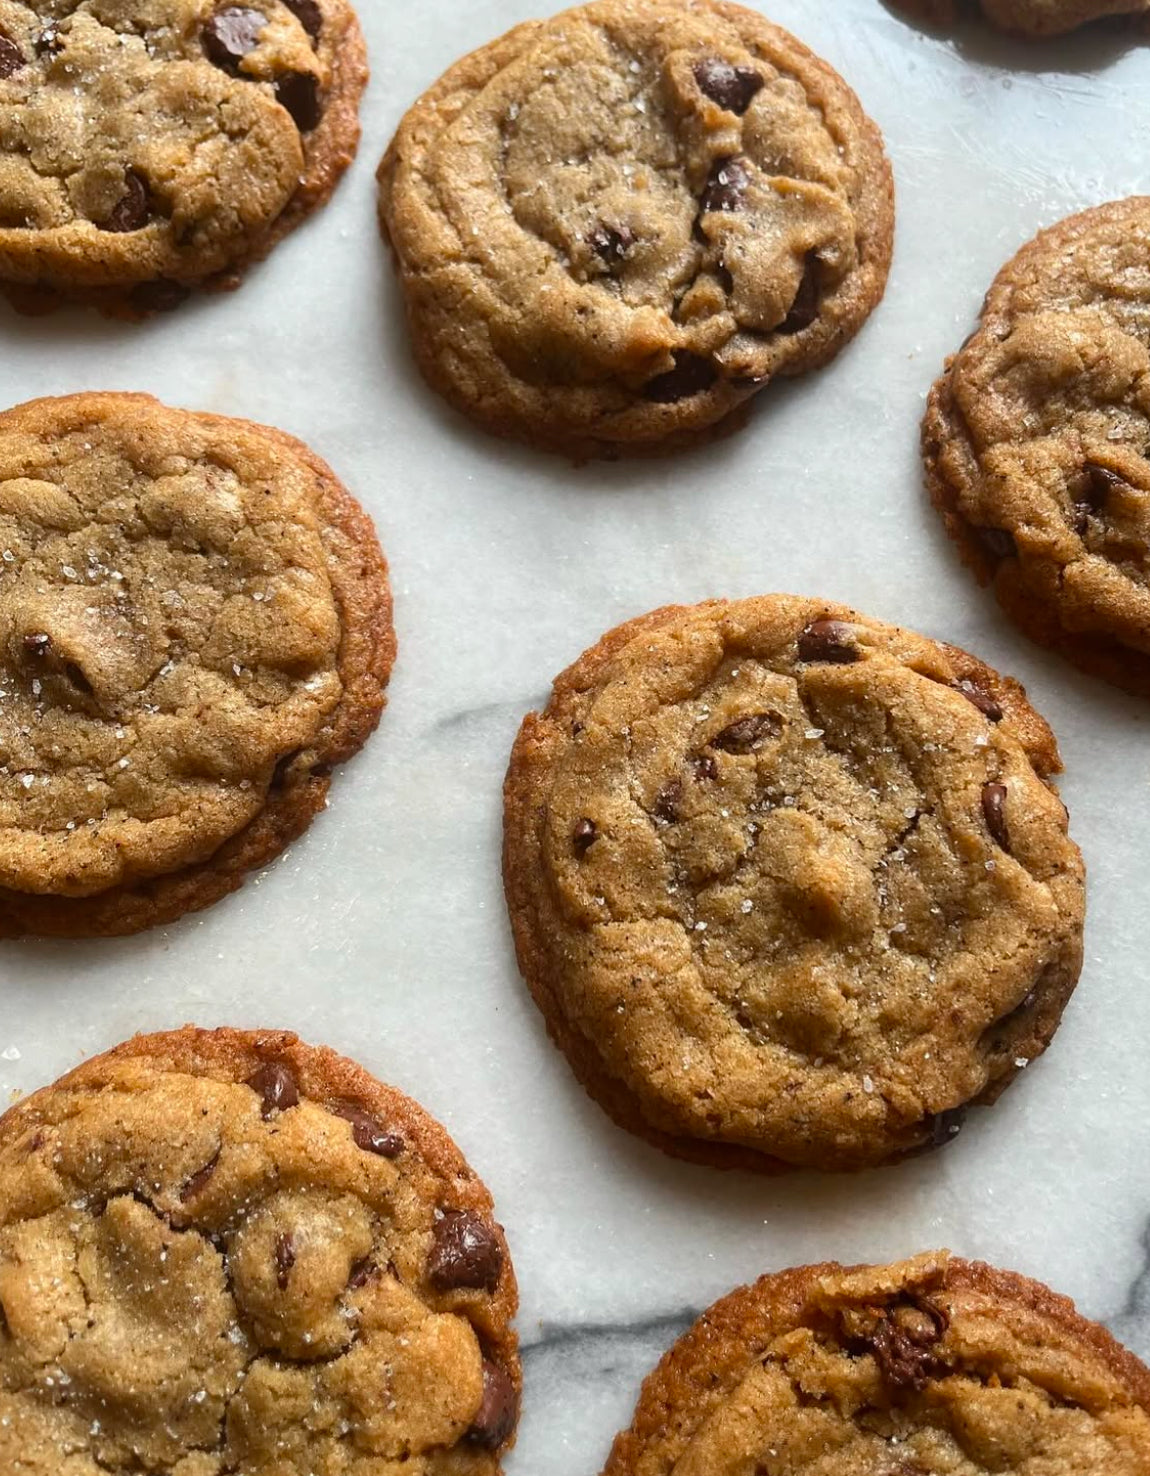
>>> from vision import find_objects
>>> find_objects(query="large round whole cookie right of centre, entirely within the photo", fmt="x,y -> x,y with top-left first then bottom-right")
503,595 -> 1084,1170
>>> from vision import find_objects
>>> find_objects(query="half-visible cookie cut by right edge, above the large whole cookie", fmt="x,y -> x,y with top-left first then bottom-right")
923,196 -> 1150,697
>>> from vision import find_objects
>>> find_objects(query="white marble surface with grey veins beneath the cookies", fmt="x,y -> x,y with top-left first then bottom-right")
0,0 -> 1150,1476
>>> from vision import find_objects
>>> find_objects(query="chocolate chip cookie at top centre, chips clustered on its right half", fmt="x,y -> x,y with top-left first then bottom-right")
379,0 -> 893,455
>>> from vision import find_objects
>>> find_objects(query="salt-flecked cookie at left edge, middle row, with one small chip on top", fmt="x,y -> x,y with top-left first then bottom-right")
0,394 -> 396,937
